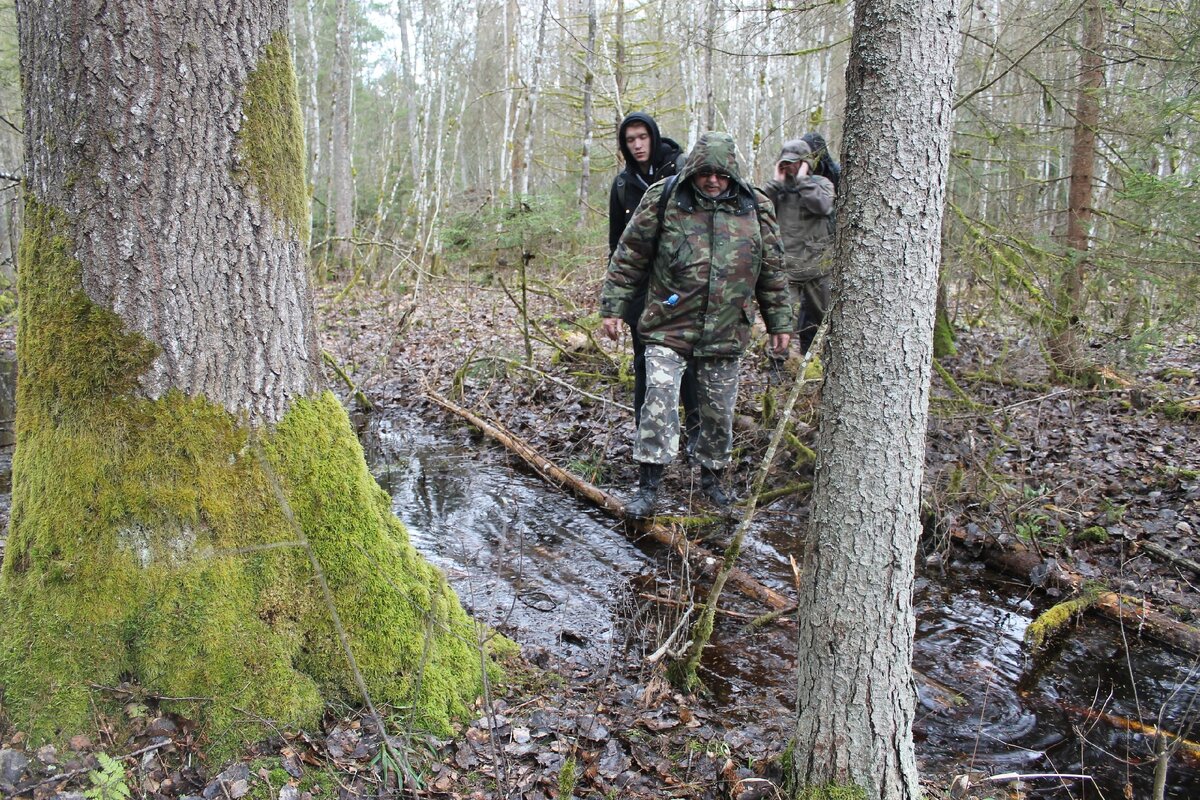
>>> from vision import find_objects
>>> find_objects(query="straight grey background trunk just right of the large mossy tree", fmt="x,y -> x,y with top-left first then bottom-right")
330,0 -> 354,261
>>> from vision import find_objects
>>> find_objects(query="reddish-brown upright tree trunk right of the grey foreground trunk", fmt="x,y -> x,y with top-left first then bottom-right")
1049,0 -> 1104,379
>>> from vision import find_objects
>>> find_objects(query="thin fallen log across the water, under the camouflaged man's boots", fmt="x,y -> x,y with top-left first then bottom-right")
425,390 -> 796,609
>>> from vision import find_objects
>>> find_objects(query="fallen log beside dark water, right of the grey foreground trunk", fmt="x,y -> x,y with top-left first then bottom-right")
950,531 -> 1200,657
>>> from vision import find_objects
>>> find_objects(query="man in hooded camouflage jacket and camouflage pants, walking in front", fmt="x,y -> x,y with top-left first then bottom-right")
600,132 -> 792,517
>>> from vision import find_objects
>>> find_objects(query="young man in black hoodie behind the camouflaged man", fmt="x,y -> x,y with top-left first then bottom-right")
608,112 -> 700,453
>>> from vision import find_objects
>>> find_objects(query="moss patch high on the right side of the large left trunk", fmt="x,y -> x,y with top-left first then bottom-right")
238,31 -> 310,243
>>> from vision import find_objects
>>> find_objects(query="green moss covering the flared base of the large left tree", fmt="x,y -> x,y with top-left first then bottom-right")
0,201 -> 481,746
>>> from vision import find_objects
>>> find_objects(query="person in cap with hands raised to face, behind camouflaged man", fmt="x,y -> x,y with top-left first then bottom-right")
763,139 -> 834,353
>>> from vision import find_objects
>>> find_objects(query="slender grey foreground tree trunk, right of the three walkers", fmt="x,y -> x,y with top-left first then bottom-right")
788,0 -> 959,800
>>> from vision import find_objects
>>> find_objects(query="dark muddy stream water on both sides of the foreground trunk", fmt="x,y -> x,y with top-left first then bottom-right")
365,415 -> 1200,800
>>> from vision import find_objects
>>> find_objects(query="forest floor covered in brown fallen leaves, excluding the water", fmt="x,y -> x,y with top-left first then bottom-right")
0,268 -> 1200,800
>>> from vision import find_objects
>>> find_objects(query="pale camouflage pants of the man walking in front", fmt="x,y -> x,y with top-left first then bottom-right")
634,344 -> 740,469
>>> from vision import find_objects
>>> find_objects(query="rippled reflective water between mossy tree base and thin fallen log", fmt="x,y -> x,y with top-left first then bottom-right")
366,417 -> 650,657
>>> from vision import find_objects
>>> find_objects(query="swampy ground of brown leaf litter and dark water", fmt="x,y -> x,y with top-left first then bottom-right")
0,272 -> 1200,800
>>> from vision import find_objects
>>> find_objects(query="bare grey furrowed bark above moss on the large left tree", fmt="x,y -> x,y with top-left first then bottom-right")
18,0 -> 319,420
